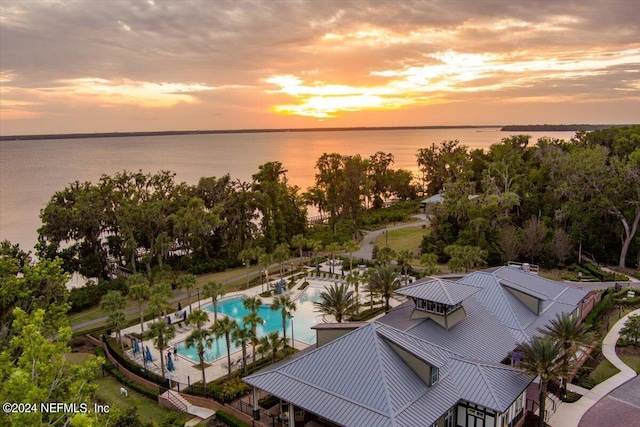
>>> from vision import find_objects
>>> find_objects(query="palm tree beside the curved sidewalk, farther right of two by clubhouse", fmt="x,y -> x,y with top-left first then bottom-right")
538,313 -> 591,397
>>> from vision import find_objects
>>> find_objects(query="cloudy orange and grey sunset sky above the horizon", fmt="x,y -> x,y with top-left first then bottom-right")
0,0 -> 640,135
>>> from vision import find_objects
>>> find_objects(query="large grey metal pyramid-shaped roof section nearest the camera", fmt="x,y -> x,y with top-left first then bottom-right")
244,321 -> 533,427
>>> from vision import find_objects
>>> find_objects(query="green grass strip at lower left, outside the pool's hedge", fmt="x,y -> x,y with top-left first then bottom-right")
94,375 -> 193,424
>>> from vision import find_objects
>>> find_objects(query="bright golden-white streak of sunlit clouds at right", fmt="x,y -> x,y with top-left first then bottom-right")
266,46 -> 640,118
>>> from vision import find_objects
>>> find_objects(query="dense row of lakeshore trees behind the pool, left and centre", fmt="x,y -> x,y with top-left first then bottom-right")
36,152 -> 415,278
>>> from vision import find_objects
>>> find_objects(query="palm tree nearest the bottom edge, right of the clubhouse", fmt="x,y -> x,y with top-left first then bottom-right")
518,337 -> 561,427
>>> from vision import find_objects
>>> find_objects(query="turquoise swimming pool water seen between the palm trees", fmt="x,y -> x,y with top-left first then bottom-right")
177,287 -> 322,362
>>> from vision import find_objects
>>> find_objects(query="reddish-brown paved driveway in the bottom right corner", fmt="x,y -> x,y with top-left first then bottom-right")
579,377 -> 640,427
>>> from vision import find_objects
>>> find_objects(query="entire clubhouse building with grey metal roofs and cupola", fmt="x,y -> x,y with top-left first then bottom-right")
244,266 -> 588,427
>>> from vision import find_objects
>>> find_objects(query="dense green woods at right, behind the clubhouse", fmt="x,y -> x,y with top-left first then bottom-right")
418,126 -> 640,268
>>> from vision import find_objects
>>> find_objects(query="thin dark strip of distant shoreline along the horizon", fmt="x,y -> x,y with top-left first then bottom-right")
0,125 -> 627,141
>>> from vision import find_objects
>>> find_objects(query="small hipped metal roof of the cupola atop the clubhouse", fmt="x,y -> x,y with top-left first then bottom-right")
395,279 -> 481,305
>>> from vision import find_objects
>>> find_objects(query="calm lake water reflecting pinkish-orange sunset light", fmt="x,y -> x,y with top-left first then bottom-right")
0,128 -> 574,250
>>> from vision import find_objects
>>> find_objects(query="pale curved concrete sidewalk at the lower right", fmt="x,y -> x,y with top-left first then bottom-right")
549,309 -> 640,427
